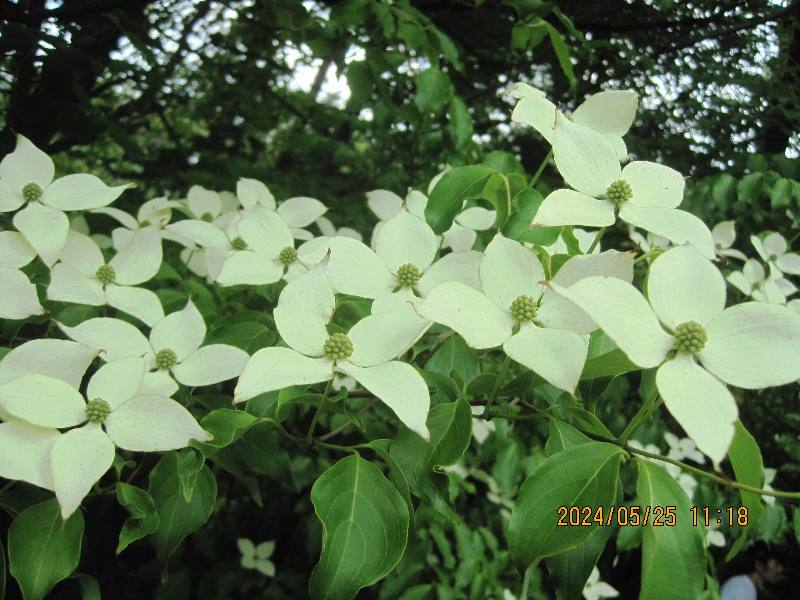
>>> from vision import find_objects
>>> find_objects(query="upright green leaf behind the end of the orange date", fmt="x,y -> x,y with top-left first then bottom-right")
636,460 -> 706,600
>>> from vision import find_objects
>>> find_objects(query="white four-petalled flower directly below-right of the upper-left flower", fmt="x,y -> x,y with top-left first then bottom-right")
47,227 -> 164,325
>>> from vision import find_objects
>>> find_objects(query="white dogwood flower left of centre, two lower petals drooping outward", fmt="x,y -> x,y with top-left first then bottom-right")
234,266 -> 430,439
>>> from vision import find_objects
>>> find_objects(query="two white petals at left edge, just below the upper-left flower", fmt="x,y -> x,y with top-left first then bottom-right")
0,231 -> 44,319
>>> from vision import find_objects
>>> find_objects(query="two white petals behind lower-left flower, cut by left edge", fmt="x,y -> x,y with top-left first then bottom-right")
0,339 -> 97,490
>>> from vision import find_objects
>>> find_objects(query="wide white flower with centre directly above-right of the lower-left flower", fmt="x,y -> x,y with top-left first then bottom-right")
59,300 -> 249,386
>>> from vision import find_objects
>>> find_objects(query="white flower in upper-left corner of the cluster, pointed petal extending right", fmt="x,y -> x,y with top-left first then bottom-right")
0,135 -> 133,267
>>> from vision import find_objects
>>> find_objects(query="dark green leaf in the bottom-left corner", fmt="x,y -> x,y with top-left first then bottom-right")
8,499 -> 84,600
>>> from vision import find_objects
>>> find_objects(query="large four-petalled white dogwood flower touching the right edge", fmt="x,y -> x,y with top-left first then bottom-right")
551,246 -> 800,464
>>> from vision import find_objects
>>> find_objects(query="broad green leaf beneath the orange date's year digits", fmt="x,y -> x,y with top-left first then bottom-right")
509,442 -> 624,570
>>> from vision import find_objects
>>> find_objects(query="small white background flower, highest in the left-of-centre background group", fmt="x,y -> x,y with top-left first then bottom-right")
236,177 -> 328,240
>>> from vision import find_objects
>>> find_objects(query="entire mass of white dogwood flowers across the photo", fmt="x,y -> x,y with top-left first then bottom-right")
0,84 -> 800,528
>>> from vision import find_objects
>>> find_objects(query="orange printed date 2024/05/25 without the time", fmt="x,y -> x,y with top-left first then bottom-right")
556,505 -> 678,527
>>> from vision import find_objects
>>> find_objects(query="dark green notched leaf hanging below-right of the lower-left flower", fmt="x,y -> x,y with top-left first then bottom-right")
148,452 -> 217,563
